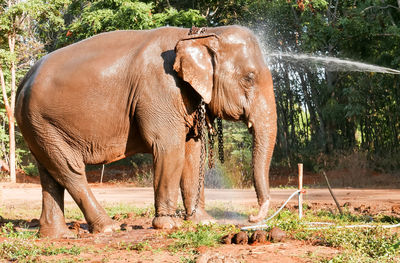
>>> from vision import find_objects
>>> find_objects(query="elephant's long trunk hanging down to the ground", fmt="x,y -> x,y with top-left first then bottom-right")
249,72 -> 277,222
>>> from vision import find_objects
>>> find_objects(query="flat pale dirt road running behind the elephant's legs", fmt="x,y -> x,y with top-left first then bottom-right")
0,183 -> 400,216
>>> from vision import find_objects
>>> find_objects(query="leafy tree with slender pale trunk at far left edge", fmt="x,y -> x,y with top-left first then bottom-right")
0,0 -> 66,182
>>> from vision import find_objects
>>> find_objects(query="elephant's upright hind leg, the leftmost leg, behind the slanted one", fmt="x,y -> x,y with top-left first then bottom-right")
39,164 -> 73,238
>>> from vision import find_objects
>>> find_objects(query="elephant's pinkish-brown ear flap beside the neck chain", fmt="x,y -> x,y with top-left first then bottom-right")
174,34 -> 218,103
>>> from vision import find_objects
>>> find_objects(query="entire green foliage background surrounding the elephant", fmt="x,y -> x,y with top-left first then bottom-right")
0,0 -> 400,187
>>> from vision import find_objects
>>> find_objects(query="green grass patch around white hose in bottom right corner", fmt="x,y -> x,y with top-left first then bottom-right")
260,209 -> 400,263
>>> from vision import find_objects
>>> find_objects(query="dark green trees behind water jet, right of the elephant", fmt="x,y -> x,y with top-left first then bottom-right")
238,0 -> 400,172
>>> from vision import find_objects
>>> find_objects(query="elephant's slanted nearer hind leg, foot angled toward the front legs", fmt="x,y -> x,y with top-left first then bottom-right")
36,134 -> 119,233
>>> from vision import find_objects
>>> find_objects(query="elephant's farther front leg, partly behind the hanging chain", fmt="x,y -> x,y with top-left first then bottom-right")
180,138 -> 213,223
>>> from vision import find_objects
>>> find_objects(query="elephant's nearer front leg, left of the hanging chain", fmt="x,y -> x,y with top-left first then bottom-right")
153,145 -> 185,229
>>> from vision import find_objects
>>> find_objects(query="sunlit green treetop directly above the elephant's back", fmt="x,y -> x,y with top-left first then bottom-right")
42,0 -> 206,51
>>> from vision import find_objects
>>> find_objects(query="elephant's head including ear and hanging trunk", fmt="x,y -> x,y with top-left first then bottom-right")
174,26 -> 277,221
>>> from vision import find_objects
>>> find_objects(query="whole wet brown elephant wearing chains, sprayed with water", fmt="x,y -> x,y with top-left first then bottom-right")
15,25 -> 277,237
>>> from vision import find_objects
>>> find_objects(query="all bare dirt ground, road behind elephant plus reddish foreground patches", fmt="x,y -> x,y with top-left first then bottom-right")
0,183 -> 400,263
